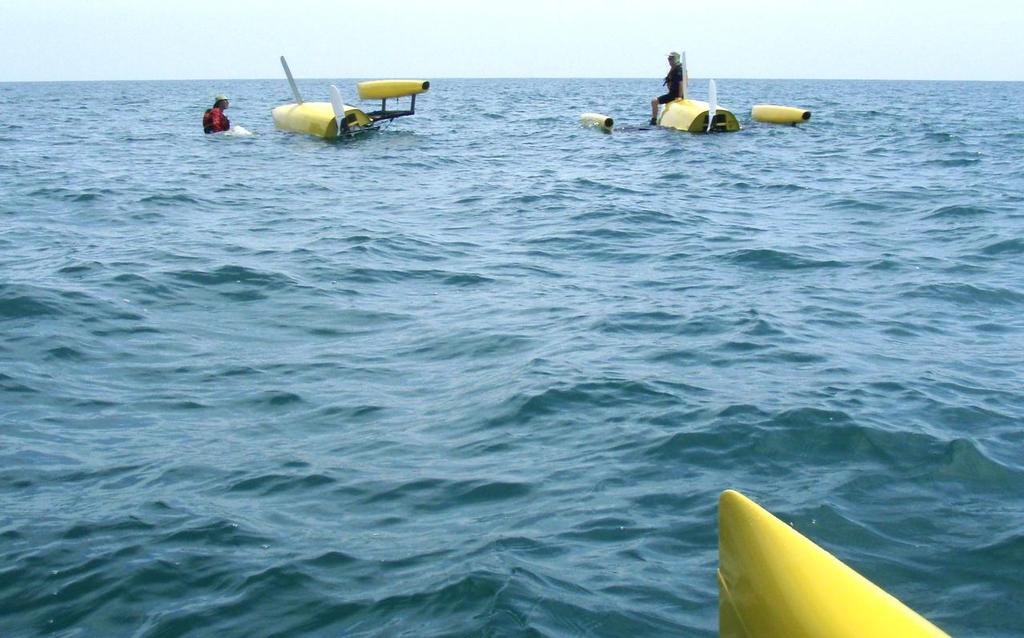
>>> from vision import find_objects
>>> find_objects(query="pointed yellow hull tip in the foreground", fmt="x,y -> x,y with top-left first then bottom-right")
718,490 -> 948,638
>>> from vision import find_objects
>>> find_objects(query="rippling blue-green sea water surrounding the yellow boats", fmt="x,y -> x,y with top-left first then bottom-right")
0,80 -> 1024,638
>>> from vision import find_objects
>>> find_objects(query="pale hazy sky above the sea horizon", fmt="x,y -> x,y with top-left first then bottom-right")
0,0 -> 1024,82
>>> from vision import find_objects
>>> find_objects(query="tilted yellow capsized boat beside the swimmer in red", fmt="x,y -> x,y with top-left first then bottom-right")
271,55 -> 430,139
